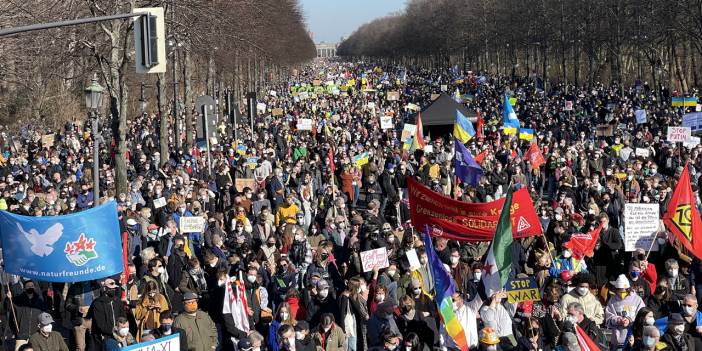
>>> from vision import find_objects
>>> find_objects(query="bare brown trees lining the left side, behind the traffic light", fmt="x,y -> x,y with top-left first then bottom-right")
0,0 -> 316,192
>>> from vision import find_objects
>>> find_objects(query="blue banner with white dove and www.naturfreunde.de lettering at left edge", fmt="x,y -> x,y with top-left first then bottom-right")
0,201 -> 124,282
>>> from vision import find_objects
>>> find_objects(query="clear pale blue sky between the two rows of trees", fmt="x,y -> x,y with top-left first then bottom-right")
300,0 -> 405,43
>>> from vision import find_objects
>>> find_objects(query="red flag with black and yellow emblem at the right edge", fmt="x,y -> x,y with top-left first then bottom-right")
663,164 -> 702,258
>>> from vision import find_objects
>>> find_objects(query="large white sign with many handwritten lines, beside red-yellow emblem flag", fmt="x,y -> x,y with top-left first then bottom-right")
624,203 -> 660,251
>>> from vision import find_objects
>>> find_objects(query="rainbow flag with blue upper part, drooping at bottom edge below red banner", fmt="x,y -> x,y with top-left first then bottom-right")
424,228 -> 468,351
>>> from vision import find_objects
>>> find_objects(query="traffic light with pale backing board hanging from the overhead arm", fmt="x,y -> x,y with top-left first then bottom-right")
132,7 -> 166,73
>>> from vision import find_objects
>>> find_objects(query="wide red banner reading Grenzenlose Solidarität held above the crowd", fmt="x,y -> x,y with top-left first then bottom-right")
407,178 -> 542,242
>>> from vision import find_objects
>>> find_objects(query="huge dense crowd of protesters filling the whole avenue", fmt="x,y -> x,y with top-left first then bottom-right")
0,61 -> 702,351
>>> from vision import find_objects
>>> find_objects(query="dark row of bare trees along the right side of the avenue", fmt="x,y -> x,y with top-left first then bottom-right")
337,0 -> 702,91
